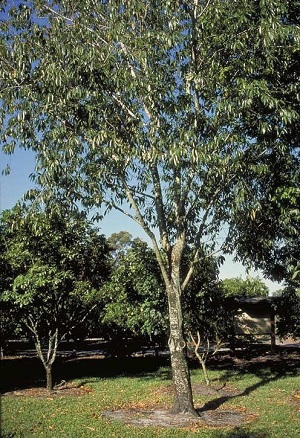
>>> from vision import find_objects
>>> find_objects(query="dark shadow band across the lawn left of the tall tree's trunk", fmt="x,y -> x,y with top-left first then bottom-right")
0,357 -> 171,393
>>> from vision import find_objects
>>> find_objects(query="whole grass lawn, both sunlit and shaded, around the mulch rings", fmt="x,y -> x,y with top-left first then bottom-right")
0,352 -> 300,438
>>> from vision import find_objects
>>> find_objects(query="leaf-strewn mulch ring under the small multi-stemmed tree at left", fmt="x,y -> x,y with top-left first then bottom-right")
2,380 -> 93,398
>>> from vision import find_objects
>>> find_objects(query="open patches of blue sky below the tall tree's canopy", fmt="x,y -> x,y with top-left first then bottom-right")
0,149 -> 280,293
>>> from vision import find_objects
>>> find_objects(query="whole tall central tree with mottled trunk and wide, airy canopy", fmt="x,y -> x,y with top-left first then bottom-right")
0,0 -> 299,415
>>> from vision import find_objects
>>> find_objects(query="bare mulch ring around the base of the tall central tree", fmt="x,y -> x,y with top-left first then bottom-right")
102,408 -> 254,428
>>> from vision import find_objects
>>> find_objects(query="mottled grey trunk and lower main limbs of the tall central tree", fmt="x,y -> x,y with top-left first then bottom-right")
135,188 -> 199,417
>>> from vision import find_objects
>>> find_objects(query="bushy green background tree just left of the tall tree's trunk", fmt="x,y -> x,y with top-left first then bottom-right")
98,232 -> 168,348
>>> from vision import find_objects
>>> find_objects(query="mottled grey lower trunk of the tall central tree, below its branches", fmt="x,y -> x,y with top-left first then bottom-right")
168,285 -> 198,416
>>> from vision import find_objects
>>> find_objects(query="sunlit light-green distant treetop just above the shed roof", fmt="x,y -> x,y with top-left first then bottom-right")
222,277 -> 269,298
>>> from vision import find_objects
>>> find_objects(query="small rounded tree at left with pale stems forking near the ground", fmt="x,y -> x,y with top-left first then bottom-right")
1,205 -> 109,390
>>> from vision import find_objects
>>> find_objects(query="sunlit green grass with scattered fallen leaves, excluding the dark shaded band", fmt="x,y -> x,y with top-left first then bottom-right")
1,354 -> 300,438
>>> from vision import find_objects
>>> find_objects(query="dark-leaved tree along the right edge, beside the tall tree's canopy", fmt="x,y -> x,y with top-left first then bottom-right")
225,1 -> 300,287
